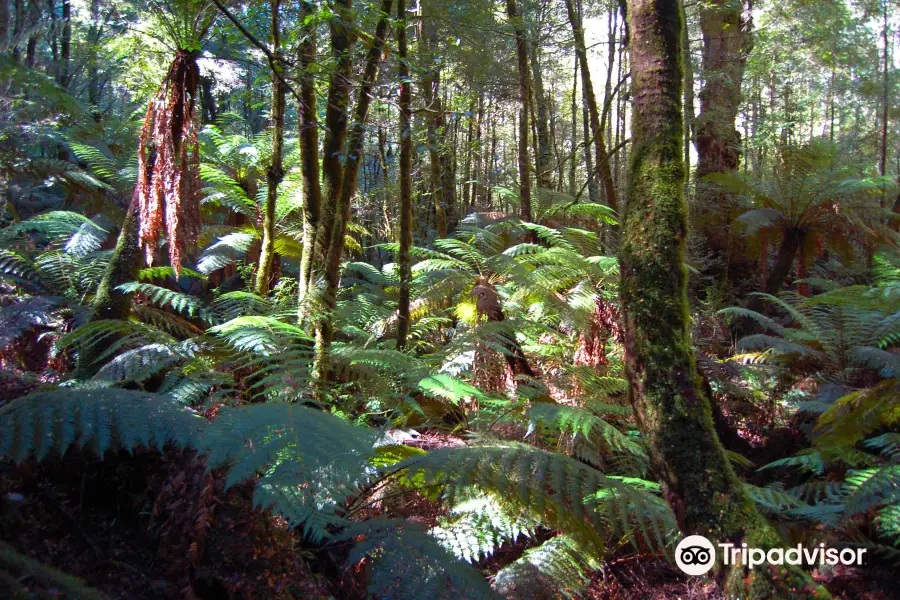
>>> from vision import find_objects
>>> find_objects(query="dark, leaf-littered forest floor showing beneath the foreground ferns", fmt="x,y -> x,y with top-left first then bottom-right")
0,432 -> 900,600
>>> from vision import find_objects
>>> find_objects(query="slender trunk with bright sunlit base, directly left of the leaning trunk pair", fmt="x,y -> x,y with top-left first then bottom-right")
297,0 -> 322,322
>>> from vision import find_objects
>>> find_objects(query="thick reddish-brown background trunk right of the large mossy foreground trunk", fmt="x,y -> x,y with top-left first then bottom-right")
694,0 -> 750,251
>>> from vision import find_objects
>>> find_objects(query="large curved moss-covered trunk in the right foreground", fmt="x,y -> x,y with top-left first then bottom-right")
619,0 -> 827,599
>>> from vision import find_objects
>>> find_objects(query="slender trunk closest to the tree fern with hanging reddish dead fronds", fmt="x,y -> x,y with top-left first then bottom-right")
253,0 -> 287,296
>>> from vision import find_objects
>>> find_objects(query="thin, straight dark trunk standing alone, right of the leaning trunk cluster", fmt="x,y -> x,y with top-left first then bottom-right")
397,0 -> 414,350
